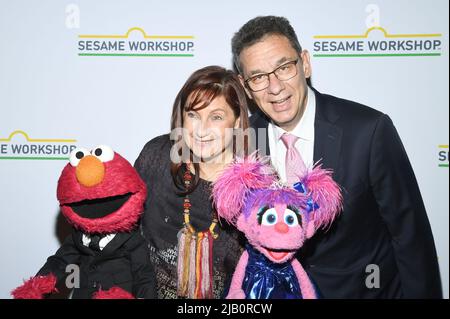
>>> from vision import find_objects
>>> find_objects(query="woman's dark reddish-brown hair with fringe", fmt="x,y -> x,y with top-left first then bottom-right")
170,66 -> 249,195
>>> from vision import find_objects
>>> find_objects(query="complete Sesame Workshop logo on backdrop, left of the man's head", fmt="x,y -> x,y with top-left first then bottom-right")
78,27 -> 195,57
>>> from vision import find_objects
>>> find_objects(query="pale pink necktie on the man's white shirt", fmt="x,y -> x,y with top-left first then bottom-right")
281,133 -> 306,185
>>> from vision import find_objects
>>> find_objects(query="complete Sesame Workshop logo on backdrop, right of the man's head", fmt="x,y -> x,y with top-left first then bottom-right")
313,26 -> 442,58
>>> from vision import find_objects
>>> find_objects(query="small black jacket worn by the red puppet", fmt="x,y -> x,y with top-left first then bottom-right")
38,229 -> 156,299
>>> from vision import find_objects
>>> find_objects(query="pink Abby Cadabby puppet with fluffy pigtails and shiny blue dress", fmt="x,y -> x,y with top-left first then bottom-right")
213,154 -> 342,299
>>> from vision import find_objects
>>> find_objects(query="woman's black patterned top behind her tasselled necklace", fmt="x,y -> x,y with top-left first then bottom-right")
135,134 -> 244,298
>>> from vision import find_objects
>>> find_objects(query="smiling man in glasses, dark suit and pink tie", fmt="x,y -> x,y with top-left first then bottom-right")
232,16 -> 442,298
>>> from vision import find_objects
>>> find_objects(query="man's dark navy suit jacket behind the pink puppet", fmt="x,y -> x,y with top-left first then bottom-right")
250,90 -> 442,298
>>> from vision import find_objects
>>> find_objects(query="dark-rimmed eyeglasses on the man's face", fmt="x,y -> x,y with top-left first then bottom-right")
245,59 -> 299,92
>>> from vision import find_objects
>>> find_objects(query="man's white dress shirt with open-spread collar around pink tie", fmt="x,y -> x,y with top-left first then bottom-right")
268,87 -> 316,182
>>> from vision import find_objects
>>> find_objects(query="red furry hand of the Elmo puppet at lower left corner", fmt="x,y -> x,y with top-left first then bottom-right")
11,274 -> 58,299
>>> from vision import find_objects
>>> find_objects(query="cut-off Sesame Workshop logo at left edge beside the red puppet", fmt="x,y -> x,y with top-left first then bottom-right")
0,130 -> 76,160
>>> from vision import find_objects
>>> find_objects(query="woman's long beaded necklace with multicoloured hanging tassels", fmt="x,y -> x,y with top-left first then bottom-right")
177,164 -> 219,299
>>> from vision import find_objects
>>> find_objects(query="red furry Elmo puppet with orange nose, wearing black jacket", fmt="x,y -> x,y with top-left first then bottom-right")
12,145 -> 156,299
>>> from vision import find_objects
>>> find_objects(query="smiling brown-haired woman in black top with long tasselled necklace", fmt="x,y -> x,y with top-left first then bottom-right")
135,66 -> 248,298
